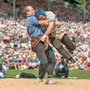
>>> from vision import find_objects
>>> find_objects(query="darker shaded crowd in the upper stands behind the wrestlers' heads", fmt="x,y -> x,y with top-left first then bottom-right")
0,0 -> 90,22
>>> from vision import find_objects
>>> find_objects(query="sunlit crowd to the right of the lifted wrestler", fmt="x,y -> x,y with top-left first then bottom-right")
62,21 -> 90,69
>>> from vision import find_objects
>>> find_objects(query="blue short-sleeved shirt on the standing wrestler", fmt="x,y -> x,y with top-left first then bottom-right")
26,16 -> 43,38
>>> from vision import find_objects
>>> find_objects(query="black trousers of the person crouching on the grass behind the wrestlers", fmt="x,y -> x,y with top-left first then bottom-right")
55,67 -> 69,78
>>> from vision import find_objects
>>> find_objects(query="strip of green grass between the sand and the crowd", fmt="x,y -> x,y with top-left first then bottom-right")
6,69 -> 90,79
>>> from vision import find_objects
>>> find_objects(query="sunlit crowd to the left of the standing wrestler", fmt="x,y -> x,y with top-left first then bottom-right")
0,18 -> 40,70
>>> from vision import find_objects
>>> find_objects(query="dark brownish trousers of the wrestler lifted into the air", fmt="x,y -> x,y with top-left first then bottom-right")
49,34 -> 75,60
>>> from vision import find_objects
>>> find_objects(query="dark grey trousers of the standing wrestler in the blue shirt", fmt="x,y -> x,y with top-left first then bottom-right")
35,42 -> 56,79
